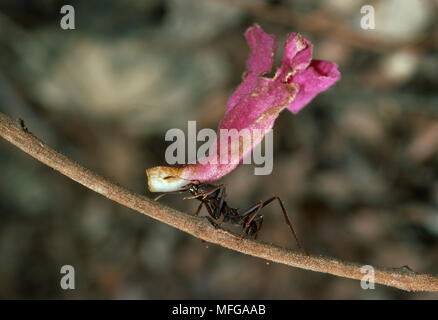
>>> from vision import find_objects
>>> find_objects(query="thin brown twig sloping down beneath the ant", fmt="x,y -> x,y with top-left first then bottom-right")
0,113 -> 438,291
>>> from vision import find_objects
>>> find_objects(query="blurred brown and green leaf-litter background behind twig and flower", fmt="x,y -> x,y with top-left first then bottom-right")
0,0 -> 438,299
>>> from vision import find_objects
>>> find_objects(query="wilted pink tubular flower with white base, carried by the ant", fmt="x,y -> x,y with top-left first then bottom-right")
147,25 -> 340,192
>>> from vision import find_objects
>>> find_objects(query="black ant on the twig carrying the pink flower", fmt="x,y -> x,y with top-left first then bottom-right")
154,176 -> 308,255
